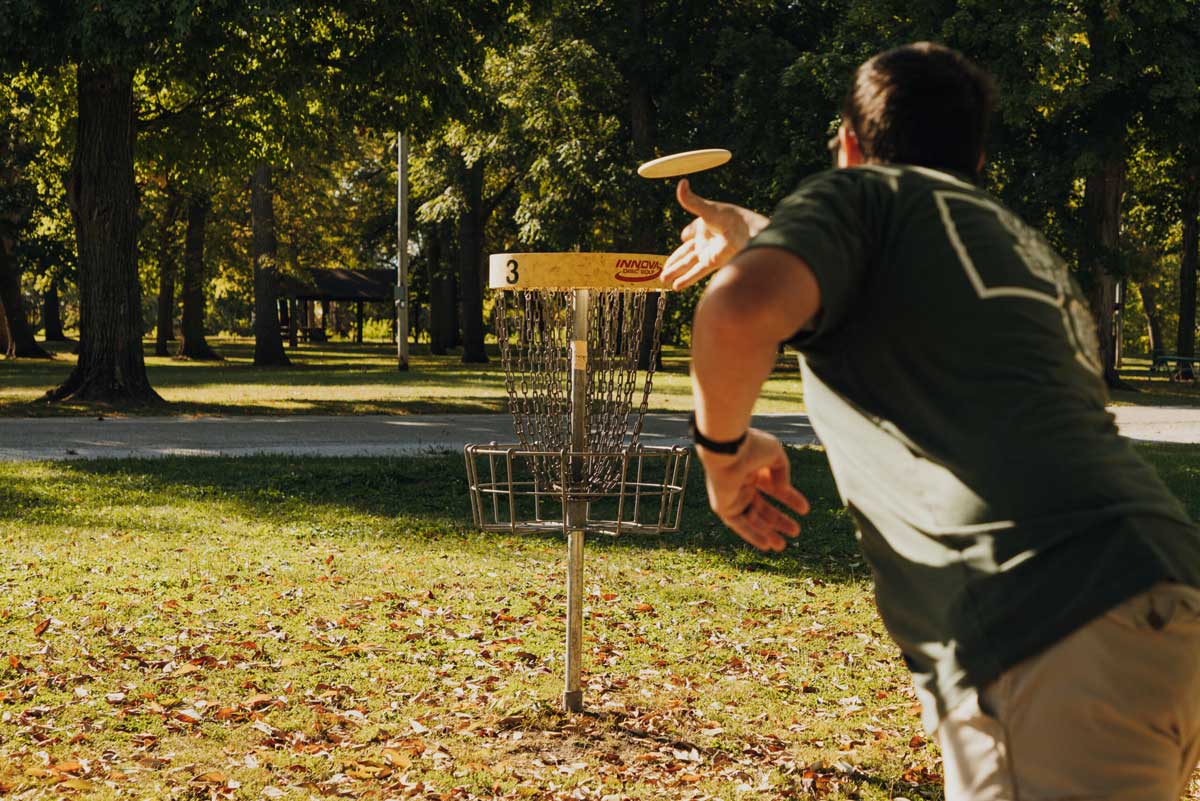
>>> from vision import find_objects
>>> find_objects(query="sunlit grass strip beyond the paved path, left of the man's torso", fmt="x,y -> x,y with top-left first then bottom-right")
0,339 -> 803,416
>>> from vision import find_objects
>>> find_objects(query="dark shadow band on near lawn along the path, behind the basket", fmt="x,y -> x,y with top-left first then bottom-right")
21,448 -> 866,580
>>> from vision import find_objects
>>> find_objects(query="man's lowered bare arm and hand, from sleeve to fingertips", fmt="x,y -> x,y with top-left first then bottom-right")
691,247 -> 821,550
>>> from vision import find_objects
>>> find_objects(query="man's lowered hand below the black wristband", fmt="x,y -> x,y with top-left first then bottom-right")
696,428 -> 809,550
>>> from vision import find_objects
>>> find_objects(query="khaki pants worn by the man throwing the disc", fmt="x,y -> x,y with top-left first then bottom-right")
937,584 -> 1200,801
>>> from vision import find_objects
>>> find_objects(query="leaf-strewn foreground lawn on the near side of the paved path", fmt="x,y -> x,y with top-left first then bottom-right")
0,446 -> 1200,800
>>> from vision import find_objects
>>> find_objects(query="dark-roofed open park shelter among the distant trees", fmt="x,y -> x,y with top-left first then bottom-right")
277,267 -> 396,347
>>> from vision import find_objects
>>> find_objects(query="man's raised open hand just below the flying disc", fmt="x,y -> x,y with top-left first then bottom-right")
662,179 -> 770,289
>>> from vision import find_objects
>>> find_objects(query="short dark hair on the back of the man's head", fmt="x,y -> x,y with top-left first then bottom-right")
841,42 -> 996,175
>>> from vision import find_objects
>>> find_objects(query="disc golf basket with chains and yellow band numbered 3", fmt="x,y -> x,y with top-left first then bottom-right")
466,253 -> 689,711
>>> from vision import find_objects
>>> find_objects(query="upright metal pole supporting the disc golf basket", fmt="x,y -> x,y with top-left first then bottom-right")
563,289 -> 588,712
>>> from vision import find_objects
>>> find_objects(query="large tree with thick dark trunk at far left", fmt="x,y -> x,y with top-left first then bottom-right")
0,0 -> 260,404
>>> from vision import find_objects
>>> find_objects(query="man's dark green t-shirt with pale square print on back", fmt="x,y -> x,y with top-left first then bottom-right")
749,165 -> 1200,729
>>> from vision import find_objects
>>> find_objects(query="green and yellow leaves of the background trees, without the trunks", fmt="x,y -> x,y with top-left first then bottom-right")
0,0 -> 1200,350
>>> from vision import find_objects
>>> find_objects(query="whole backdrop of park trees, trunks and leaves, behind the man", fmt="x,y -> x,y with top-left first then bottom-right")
0,0 -> 1200,393
